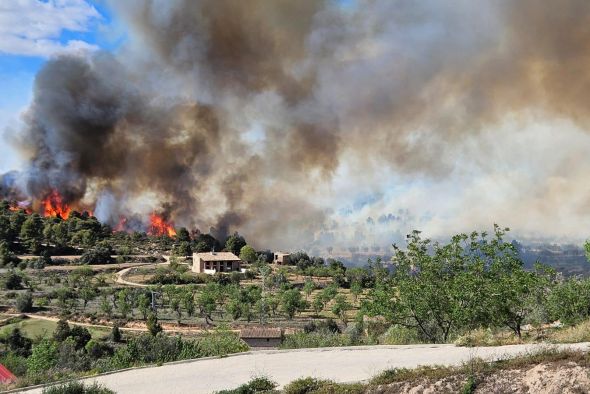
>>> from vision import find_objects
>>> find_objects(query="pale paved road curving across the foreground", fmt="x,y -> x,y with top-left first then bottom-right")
17,342 -> 590,394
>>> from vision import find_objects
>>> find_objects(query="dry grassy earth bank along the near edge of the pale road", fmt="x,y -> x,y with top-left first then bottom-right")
218,348 -> 590,394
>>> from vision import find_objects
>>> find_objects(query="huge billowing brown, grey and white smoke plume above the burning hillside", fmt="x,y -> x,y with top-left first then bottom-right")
5,0 -> 590,247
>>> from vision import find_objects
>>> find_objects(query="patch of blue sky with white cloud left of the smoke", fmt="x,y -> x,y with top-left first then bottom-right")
0,0 -> 118,173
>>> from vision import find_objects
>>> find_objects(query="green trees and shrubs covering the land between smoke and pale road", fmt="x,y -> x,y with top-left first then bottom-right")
0,202 -> 590,390
